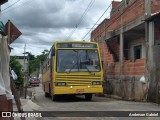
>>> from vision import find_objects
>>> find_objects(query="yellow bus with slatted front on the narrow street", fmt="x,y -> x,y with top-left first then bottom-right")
42,41 -> 103,101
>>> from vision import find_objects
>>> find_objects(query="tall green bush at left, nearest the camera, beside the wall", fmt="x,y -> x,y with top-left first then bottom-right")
10,56 -> 24,87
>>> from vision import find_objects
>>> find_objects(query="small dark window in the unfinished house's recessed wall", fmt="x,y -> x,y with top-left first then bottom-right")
134,45 -> 142,60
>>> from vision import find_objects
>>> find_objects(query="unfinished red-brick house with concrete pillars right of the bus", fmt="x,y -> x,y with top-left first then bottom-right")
91,0 -> 160,103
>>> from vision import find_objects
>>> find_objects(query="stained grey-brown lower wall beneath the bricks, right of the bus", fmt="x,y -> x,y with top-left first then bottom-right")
104,76 -> 148,101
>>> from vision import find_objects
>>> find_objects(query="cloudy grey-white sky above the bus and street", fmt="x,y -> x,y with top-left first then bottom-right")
1,0 -> 119,55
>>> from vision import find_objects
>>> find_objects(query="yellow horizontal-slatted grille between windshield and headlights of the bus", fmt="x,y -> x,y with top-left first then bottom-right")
56,75 -> 101,86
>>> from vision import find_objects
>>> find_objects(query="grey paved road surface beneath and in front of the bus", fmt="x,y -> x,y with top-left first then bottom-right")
30,84 -> 160,120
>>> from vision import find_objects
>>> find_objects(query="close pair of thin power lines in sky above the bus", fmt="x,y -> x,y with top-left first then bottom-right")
67,0 -> 95,39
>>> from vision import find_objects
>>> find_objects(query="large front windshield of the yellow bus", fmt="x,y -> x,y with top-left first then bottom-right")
57,50 -> 100,72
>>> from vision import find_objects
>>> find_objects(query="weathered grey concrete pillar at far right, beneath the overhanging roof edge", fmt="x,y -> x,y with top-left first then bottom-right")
146,21 -> 156,102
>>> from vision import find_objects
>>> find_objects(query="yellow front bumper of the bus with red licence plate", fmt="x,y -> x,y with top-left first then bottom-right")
53,85 -> 103,95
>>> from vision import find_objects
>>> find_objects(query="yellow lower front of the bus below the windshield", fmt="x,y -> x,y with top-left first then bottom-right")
52,72 -> 103,95
